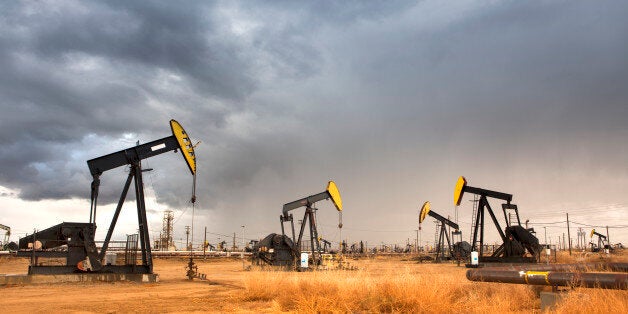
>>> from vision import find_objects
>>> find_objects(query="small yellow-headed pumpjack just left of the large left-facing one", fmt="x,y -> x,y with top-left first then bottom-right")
419,201 -> 470,262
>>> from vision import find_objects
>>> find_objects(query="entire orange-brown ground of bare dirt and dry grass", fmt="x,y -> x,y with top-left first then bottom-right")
0,253 -> 628,313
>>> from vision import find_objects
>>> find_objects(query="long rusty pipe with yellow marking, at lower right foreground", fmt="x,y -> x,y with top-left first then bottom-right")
467,268 -> 628,290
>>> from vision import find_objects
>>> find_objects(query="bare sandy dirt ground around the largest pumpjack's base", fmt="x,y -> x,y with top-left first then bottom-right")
0,258 -> 270,313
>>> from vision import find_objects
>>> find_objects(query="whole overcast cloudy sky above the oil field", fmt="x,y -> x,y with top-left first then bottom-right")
0,1 -> 628,250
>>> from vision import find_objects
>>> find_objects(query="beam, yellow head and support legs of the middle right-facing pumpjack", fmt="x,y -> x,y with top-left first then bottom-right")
279,181 -> 342,264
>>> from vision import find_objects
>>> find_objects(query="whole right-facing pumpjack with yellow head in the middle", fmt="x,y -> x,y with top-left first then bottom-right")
253,181 -> 342,267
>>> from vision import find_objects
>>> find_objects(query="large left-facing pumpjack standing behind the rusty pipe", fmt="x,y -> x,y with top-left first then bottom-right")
454,176 -> 541,263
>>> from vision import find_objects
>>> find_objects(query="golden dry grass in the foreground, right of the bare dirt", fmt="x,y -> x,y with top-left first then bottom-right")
239,254 -> 628,313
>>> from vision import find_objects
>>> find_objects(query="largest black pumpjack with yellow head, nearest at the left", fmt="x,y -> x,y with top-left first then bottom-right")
18,120 -> 196,274
